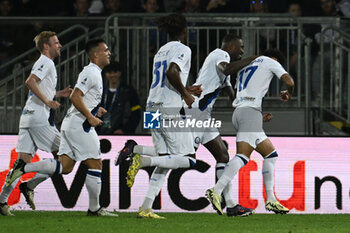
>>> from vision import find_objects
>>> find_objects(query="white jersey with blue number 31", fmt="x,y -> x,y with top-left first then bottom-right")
147,41 -> 191,108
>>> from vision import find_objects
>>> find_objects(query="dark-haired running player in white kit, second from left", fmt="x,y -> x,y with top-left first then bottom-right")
6,39 -> 118,217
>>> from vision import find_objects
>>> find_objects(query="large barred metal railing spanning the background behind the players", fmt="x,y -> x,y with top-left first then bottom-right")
0,14 -> 345,135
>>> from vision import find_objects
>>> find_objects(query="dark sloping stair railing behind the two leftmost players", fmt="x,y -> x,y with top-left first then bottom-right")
0,22 -> 97,133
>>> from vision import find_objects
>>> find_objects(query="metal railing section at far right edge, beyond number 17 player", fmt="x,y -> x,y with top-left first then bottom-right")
316,24 -> 350,133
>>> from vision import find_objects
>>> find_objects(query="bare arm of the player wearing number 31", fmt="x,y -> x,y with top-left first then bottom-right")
166,62 -> 194,108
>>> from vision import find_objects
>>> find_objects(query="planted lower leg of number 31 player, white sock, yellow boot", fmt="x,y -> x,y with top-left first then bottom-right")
137,167 -> 169,219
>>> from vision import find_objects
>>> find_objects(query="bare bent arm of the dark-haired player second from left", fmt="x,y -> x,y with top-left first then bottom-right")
70,88 -> 102,127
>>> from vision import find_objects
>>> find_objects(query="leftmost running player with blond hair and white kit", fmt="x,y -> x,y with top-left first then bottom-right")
0,31 -> 72,216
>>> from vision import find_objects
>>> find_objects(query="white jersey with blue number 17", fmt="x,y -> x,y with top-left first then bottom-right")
232,56 -> 287,110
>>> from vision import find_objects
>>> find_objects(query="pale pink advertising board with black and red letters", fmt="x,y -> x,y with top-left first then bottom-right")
0,135 -> 350,213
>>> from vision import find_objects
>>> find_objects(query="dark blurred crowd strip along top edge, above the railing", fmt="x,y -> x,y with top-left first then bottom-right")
0,0 -> 349,16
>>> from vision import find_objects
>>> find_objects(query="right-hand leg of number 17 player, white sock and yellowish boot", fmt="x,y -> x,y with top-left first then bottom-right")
255,138 -> 289,214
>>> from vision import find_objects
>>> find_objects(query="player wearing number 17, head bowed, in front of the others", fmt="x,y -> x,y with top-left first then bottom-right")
206,49 -> 294,214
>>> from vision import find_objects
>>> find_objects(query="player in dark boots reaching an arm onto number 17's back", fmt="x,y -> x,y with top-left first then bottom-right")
116,34 -> 256,216
